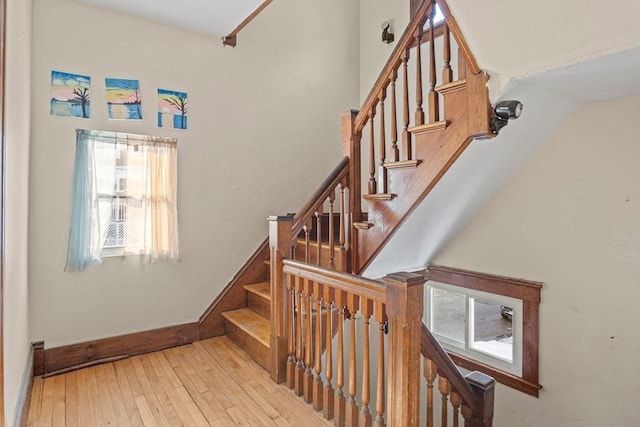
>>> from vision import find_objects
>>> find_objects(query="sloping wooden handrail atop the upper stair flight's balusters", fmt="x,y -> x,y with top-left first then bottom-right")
355,0 -> 433,133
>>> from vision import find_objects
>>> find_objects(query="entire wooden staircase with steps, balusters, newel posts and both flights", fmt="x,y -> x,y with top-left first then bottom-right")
218,0 -> 494,426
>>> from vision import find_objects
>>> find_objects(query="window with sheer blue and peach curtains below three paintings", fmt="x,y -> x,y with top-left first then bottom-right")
65,130 -> 178,271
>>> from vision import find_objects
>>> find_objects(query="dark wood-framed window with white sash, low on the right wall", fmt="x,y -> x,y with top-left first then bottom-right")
425,266 -> 542,396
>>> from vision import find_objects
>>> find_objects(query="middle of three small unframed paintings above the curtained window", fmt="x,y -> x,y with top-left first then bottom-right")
105,78 -> 142,120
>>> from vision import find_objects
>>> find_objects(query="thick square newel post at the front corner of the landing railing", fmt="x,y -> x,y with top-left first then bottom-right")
384,273 -> 425,427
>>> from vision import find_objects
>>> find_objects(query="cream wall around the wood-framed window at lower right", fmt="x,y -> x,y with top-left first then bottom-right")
433,97 -> 640,427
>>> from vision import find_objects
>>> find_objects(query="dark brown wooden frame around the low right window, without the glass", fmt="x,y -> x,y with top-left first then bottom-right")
424,265 -> 542,397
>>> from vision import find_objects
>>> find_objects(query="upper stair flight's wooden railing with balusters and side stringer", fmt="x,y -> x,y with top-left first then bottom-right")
342,0 -> 492,274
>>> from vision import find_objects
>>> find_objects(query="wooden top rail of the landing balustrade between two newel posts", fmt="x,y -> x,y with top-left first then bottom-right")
282,259 -> 387,303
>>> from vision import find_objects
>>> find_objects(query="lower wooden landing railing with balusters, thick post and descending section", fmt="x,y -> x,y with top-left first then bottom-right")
276,260 -> 494,427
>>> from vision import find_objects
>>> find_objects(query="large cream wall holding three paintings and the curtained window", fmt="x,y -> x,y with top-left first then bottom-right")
29,0 -> 358,347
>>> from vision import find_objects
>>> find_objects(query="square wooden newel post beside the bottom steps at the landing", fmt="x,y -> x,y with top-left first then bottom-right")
268,216 -> 293,383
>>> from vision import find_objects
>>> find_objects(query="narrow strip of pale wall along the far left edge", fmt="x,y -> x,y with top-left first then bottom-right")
3,0 -> 31,426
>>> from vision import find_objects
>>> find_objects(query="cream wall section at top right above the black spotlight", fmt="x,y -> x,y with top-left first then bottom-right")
447,0 -> 640,99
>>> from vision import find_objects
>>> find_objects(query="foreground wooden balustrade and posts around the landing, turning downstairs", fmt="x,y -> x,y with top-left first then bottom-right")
281,260 -> 495,427
